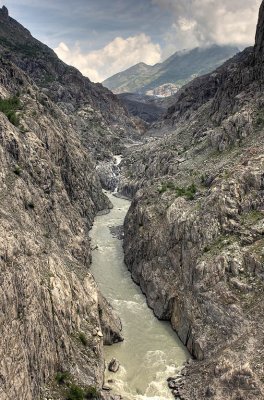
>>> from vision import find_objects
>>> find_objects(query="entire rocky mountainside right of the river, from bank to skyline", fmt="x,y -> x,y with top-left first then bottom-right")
121,4 -> 264,400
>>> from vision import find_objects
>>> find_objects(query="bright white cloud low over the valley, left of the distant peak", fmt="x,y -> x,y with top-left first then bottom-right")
54,33 -> 161,82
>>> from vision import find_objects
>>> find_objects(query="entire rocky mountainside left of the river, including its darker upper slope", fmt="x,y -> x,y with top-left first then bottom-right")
0,7 -> 142,400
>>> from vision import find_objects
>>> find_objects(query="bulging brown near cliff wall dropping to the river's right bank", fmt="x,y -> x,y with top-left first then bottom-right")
124,149 -> 264,399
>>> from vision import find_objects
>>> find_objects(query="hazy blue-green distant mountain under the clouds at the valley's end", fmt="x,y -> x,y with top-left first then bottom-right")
103,45 -> 239,95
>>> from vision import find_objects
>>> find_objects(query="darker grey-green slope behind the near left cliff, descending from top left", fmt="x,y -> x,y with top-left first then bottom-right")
0,5 -> 141,160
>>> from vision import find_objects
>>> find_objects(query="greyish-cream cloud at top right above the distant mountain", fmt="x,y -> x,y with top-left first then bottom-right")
152,0 -> 261,56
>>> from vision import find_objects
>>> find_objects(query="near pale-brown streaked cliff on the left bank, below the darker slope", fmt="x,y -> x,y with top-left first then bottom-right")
0,21 -> 121,400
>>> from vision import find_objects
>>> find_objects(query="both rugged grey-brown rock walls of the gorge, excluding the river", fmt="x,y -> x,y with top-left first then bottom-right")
0,3 -> 264,400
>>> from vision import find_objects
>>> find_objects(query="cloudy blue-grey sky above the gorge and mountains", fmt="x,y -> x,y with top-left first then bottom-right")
0,0 -> 261,82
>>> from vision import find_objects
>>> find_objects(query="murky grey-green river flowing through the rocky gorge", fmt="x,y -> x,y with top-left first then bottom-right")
91,194 -> 188,400
